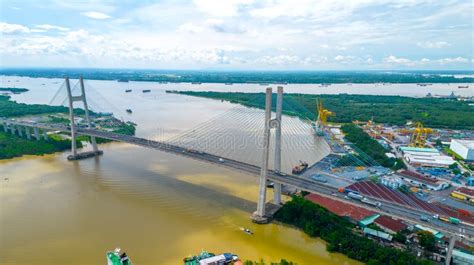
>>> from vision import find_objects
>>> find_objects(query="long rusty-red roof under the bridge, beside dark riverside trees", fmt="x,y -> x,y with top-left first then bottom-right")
305,194 -> 375,222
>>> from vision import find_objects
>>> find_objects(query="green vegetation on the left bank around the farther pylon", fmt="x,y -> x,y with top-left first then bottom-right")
0,95 -> 135,160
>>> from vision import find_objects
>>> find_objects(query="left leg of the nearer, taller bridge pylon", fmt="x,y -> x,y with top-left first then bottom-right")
254,87 -> 272,222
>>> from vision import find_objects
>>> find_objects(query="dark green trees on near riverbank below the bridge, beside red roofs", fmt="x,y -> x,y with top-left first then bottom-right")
274,196 -> 433,265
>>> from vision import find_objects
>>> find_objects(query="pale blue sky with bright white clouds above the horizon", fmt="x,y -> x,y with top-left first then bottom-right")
0,0 -> 474,70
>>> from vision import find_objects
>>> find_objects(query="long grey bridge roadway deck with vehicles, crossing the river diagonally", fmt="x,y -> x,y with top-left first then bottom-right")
0,119 -> 474,237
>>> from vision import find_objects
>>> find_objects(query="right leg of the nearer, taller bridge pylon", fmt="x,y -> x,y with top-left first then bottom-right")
273,86 -> 283,205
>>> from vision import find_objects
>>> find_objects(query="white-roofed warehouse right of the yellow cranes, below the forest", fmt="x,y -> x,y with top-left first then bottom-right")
400,147 -> 456,167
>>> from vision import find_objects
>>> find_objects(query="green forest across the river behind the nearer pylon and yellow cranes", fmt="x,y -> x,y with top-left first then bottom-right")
166,90 -> 474,130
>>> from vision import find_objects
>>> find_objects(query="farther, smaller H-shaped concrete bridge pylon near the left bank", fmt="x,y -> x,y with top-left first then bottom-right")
65,76 -> 103,160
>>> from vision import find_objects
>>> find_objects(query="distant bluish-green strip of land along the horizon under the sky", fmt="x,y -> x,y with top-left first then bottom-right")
0,68 -> 474,84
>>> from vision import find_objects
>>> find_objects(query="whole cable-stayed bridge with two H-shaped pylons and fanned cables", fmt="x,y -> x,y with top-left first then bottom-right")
0,77 -> 474,260
